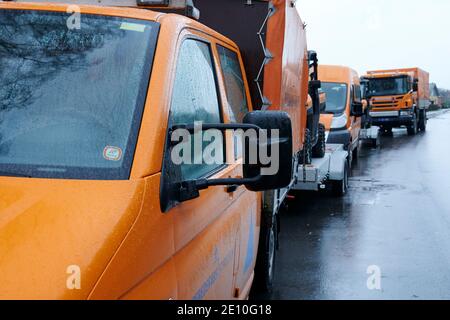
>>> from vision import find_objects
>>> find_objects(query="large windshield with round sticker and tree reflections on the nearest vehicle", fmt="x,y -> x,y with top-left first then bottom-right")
0,10 -> 159,180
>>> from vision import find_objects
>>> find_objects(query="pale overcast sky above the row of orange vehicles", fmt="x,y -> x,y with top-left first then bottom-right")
297,0 -> 450,89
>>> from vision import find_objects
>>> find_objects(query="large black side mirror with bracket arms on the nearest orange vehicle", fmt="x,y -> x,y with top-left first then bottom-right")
160,111 -> 293,212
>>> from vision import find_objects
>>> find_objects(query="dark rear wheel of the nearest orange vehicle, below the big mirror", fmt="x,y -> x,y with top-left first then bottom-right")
255,191 -> 279,293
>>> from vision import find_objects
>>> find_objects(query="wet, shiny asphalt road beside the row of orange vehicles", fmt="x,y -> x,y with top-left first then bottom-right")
270,113 -> 450,299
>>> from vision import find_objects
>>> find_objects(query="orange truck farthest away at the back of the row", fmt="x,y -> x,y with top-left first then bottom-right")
364,68 -> 430,135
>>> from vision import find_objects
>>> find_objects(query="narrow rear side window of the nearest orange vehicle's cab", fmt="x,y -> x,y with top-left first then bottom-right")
217,46 -> 248,123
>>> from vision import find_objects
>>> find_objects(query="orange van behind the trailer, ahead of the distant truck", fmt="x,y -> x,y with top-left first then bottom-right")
319,65 -> 363,164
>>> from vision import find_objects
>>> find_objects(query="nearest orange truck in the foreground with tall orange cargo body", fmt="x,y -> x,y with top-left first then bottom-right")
0,0 -> 309,299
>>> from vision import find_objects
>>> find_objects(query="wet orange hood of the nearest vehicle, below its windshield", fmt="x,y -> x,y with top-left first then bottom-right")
0,178 -> 145,299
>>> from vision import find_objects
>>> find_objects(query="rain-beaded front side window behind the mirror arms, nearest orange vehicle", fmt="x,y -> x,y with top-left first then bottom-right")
171,39 -> 224,180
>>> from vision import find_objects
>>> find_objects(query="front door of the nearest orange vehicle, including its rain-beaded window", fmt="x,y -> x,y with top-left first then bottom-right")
168,34 -> 256,299
